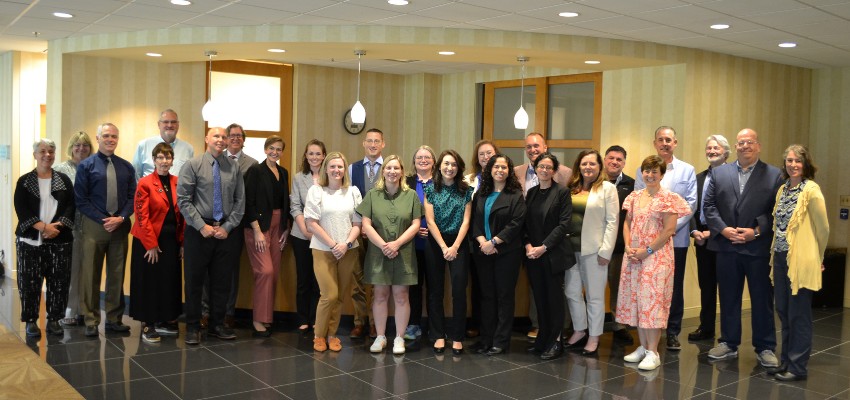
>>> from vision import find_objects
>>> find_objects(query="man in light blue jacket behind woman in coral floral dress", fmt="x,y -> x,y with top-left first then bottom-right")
635,126 -> 697,350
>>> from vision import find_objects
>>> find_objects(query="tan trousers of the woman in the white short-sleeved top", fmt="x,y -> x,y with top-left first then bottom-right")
313,249 -> 360,338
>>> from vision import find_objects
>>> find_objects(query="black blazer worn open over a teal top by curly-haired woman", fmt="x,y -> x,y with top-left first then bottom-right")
469,189 -> 525,254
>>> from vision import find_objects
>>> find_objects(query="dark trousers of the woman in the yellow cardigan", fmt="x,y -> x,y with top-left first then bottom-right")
773,251 -> 814,375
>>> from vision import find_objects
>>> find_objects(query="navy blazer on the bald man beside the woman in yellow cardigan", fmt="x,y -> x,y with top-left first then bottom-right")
703,160 -> 782,257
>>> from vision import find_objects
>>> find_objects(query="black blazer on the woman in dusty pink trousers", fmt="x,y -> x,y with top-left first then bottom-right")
242,161 -> 291,232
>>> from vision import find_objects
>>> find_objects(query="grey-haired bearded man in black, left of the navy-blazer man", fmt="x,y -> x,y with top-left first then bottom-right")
688,135 -> 731,340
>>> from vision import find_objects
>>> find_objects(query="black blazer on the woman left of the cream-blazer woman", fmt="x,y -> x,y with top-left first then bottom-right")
525,185 -> 576,275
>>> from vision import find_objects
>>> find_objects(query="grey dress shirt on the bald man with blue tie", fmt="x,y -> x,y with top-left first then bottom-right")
177,151 -> 245,232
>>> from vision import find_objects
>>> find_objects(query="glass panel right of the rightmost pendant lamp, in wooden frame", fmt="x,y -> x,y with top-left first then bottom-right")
548,82 -> 595,140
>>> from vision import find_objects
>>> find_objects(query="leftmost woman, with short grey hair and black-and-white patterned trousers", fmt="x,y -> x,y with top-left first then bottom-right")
14,139 -> 76,337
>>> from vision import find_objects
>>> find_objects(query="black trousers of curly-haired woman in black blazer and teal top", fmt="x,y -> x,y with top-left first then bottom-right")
474,249 -> 523,348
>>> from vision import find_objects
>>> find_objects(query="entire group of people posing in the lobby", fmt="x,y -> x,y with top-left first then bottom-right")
15,116 -> 829,380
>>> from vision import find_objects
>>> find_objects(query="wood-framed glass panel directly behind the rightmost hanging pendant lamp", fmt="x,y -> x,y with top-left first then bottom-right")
493,86 -> 537,140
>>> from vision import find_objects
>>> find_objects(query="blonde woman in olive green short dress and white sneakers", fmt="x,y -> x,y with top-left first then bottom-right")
357,155 -> 422,354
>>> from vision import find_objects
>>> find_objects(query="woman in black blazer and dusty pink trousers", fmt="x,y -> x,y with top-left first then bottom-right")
245,136 -> 290,337
